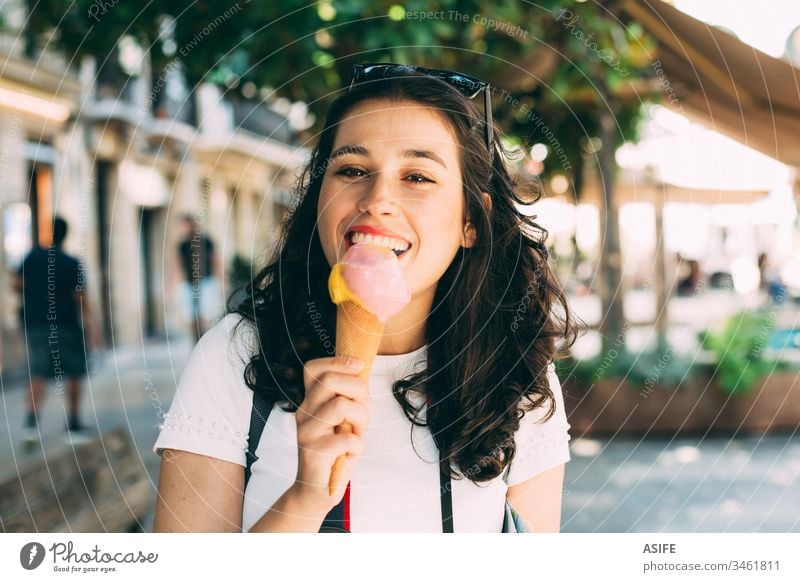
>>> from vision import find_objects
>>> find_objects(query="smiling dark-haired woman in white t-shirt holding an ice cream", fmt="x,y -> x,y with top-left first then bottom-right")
155,64 -> 574,532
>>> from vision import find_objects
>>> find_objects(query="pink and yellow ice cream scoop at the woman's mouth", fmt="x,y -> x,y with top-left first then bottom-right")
329,244 -> 411,322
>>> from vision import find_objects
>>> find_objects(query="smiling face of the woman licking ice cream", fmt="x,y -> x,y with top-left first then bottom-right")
317,100 -> 474,310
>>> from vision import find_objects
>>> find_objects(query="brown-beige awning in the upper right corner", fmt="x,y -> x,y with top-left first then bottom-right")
608,0 -> 800,167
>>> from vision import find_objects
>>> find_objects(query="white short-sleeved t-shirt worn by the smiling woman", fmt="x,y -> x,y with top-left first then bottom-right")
154,315 -> 570,532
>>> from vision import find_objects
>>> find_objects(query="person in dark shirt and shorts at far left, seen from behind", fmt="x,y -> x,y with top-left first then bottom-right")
14,217 -> 98,445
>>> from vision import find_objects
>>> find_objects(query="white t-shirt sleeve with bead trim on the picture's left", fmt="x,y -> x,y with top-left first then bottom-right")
153,315 -> 253,466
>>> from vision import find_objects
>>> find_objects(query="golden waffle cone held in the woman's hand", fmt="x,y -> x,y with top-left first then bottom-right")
328,301 -> 383,495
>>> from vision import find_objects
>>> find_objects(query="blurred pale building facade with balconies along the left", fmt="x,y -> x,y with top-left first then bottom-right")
0,2 -> 307,369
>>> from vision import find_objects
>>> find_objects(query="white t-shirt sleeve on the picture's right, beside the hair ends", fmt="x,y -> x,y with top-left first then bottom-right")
506,364 -> 570,487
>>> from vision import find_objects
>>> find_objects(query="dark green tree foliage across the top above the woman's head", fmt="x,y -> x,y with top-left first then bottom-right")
23,0 -> 653,171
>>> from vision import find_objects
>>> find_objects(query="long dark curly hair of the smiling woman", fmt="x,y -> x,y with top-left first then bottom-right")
228,72 -> 575,482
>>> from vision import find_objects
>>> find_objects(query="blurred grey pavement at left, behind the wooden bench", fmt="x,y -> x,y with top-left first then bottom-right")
0,337 -> 192,531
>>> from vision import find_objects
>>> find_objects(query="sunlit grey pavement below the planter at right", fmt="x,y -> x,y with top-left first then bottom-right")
561,430 -> 800,533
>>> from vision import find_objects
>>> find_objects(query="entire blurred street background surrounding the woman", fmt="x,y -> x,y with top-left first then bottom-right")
0,0 -> 800,532
